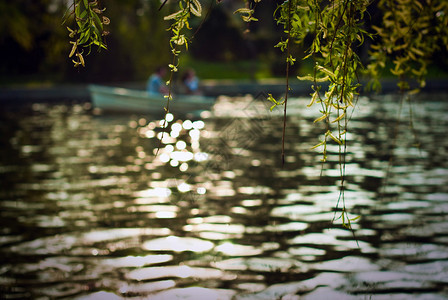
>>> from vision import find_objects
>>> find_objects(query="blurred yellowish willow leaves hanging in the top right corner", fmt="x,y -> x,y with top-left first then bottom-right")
367,0 -> 448,92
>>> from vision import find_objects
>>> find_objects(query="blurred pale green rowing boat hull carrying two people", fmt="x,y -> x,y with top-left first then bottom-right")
88,85 -> 215,114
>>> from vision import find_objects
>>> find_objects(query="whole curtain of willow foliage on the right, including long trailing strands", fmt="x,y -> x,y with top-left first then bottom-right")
234,0 -> 448,227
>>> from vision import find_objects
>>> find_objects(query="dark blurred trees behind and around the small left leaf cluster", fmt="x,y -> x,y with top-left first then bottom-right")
0,0 -> 170,82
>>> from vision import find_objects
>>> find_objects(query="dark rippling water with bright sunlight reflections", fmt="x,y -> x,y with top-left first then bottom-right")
0,95 -> 448,300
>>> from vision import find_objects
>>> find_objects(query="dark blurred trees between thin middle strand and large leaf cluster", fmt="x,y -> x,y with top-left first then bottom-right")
190,0 -> 303,76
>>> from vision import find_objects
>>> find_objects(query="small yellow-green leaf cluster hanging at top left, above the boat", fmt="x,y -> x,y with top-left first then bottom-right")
64,0 -> 110,67
